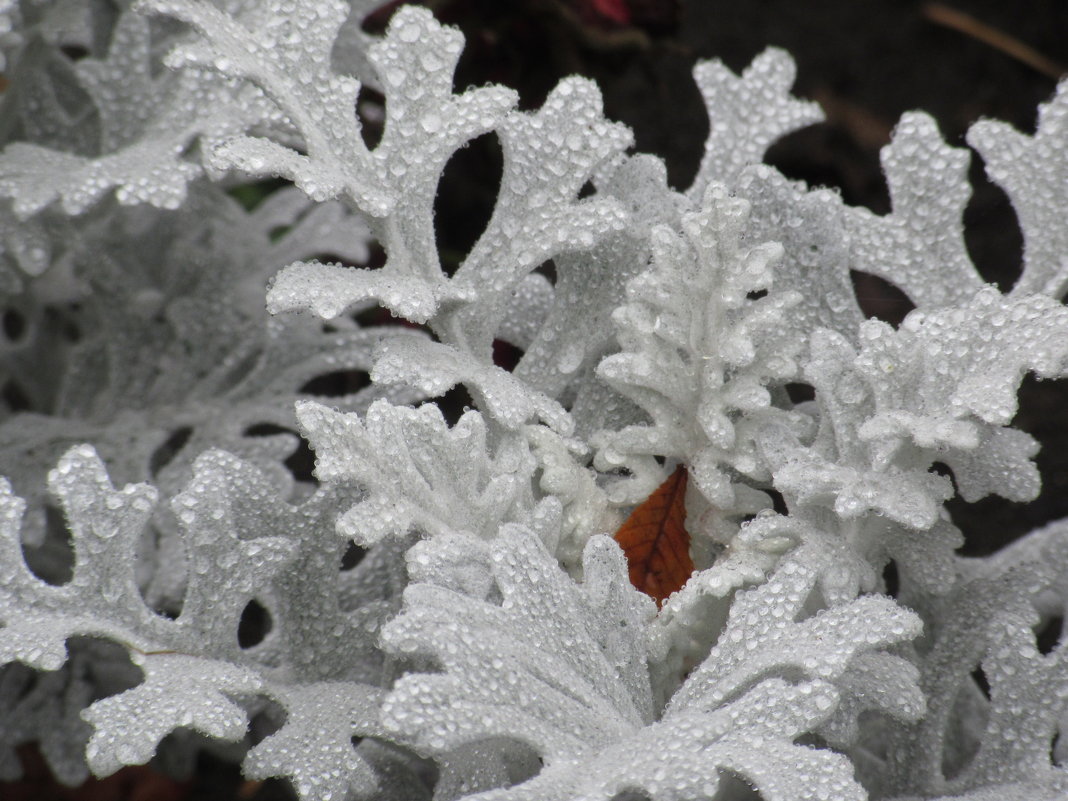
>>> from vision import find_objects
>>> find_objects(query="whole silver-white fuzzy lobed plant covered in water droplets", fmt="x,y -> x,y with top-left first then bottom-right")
0,0 -> 1068,801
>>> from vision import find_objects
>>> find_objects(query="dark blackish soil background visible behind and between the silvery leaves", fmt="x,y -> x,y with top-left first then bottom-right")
12,0 -> 1068,801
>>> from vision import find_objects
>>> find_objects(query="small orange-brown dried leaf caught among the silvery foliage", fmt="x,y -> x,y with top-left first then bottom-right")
615,466 -> 693,606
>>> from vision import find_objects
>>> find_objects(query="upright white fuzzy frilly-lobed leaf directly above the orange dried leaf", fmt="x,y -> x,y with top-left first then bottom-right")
594,185 -> 801,507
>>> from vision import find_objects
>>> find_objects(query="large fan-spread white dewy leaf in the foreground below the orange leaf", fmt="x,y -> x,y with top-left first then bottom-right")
382,524 -> 922,801
